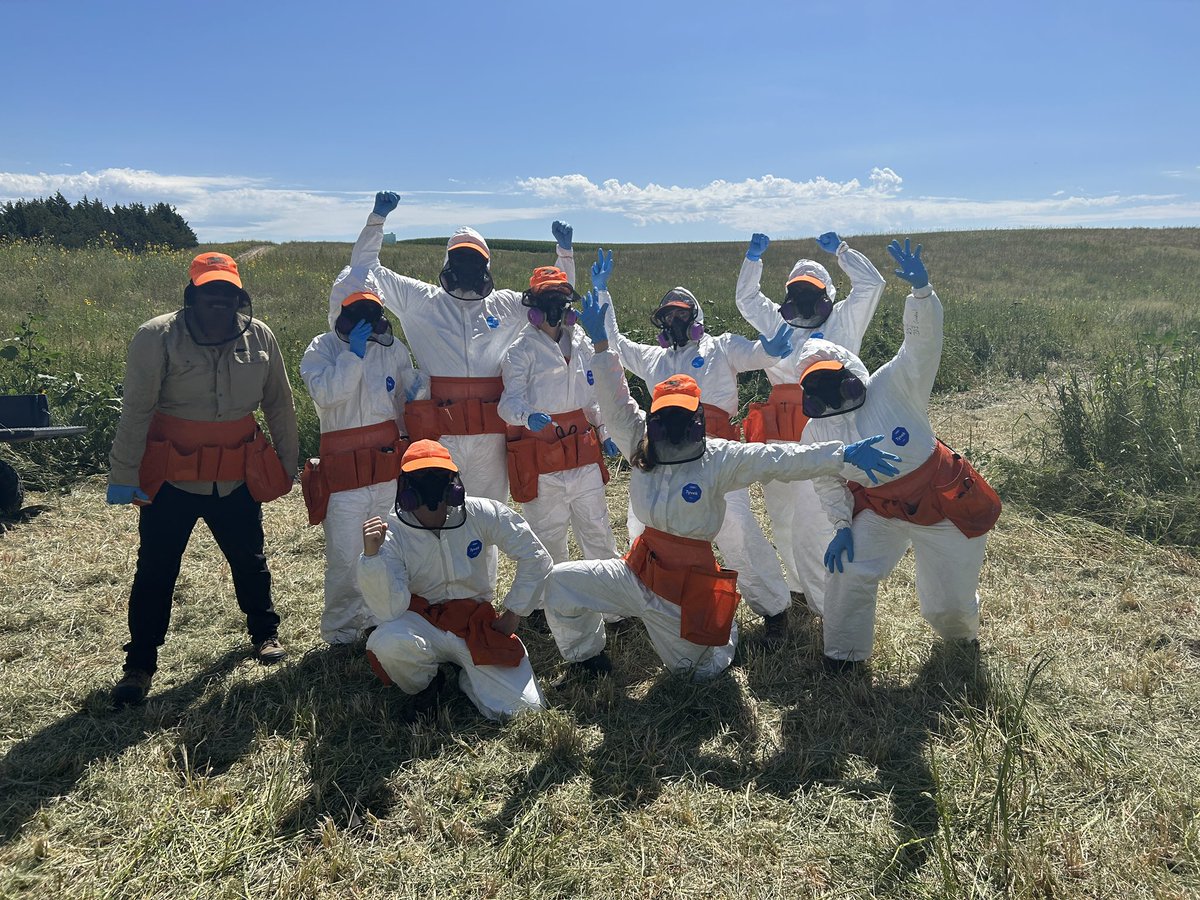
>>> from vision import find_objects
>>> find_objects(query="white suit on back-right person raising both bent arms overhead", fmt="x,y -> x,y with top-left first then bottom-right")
737,241 -> 884,614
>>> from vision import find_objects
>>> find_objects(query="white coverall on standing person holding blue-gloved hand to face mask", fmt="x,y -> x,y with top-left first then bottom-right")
300,272 -> 422,643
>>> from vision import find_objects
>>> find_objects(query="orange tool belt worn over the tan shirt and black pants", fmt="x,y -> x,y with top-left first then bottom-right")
138,413 -> 292,503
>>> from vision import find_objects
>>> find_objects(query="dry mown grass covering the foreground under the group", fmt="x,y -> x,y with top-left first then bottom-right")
0,394 -> 1200,898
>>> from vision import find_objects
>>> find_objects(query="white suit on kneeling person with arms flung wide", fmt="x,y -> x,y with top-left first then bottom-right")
542,350 -> 857,679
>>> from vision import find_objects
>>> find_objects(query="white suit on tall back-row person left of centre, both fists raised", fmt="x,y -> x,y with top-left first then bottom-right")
350,212 -> 575,503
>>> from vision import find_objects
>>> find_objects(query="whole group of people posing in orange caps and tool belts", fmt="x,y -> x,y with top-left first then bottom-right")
108,192 -> 1000,719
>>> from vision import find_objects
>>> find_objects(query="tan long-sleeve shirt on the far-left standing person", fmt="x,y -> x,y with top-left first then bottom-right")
108,310 -> 300,497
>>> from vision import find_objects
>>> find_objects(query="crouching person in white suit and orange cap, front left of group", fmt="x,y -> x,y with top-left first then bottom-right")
358,440 -> 551,719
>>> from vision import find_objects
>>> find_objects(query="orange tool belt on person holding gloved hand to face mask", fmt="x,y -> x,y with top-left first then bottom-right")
300,419 -> 408,524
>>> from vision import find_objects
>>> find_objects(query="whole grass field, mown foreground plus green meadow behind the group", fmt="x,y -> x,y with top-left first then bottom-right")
0,229 -> 1200,898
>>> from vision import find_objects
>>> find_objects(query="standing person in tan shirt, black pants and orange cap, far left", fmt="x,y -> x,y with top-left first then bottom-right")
108,253 -> 299,706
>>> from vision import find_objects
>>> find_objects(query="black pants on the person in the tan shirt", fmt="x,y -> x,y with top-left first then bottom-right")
125,484 -> 280,672
